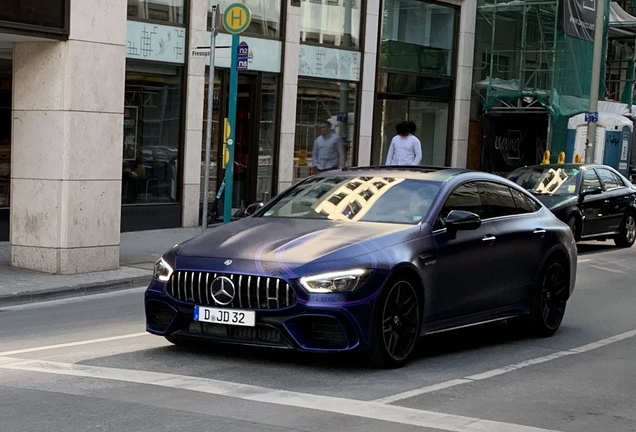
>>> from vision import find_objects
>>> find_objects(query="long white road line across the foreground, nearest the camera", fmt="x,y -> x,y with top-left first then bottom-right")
0,357 -> 555,432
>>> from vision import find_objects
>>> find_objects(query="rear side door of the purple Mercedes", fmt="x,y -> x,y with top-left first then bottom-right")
478,181 -> 548,310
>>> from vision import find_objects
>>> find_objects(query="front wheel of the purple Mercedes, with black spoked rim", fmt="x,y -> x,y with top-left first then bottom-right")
369,279 -> 422,368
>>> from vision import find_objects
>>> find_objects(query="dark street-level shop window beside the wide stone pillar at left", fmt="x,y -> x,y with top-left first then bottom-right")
122,66 -> 182,204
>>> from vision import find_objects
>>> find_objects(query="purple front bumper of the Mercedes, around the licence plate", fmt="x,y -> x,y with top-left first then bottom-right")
145,280 -> 379,352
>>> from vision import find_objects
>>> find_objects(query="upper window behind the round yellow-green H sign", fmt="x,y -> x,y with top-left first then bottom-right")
208,0 -> 283,38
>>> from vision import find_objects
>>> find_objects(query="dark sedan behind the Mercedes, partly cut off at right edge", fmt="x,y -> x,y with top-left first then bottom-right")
508,164 -> 636,247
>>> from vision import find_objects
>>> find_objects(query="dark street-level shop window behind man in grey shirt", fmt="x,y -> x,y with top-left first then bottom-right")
294,78 -> 357,181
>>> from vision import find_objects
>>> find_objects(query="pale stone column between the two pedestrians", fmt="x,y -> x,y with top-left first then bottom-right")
356,0 -> 380,166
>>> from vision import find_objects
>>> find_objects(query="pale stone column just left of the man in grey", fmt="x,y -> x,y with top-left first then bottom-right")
273,0 -> 300,194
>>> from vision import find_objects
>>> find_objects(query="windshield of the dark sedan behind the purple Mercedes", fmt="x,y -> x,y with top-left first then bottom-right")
508,165 -> 581,196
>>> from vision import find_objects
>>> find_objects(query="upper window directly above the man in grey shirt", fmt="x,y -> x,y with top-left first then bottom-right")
300,0 -> 360,49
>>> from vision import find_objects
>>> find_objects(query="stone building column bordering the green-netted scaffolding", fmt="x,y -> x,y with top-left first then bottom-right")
451,0 -> 477,168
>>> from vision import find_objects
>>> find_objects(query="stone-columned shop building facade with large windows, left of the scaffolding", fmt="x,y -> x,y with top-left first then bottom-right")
0,0 -> 476,273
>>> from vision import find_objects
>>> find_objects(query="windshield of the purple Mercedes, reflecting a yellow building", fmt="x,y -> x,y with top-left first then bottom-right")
258,176 -> 441,224
